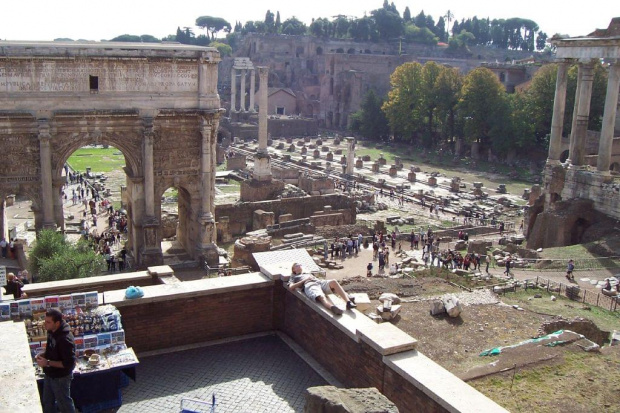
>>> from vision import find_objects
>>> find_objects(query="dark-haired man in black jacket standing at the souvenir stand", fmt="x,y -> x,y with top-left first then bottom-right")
35,308 -> 75,413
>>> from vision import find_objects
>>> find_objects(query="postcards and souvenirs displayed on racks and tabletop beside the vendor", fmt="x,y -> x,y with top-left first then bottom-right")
0,291 -> 138,373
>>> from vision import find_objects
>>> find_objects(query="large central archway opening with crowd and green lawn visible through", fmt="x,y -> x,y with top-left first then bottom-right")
64,144 -> 135,273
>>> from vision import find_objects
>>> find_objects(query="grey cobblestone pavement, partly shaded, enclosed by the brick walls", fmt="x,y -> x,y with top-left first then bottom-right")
118,336 -> 327,413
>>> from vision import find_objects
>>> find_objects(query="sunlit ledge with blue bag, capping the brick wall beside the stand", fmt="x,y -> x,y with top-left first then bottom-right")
104,272 -> 273,308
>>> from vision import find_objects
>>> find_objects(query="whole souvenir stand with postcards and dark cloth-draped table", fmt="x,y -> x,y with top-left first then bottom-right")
0,291 -> 138,413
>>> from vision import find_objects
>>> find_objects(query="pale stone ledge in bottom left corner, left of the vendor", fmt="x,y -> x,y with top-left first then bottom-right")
0,321 -> 42,413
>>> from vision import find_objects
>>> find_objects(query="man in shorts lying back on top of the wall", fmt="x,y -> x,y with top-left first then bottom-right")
288,263 -> 356,315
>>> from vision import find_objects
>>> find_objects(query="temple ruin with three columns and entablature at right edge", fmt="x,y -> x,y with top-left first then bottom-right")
527,18 -> 620,248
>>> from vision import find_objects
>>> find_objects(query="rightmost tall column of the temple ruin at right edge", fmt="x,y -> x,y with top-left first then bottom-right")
596,62 -> 620,173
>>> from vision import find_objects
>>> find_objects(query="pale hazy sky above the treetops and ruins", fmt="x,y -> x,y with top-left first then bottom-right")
0,0 -> 620,40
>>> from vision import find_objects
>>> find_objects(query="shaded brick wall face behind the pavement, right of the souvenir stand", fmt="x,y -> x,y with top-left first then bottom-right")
118,287 -> 273,353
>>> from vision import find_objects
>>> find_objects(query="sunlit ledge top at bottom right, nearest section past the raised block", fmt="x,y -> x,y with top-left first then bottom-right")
383,351 -> 508,413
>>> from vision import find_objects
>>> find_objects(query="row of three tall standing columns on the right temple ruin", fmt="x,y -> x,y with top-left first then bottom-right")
547,59 -> 620,174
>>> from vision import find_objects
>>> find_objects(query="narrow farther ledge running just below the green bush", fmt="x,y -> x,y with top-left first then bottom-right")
22,271 -> 153,297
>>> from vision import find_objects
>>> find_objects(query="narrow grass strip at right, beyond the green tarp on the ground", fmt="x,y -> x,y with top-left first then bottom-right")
502,288 -> 620,331
